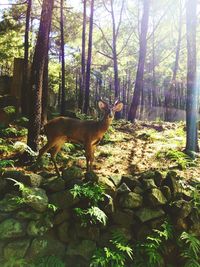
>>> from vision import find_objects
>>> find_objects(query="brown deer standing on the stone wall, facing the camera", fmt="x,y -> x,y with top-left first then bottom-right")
37,100 -> 123,176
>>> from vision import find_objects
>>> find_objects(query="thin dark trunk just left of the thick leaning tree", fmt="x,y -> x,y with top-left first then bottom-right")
21,0 -> 32,116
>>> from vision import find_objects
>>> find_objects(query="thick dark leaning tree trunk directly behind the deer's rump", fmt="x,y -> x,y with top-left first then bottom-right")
27,0 -> 54,151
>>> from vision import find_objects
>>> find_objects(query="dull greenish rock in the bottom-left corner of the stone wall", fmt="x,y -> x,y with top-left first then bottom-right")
3,239 -> 30,260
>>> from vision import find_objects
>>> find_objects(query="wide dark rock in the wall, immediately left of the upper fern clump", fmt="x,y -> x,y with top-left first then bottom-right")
49,190 -> 79,209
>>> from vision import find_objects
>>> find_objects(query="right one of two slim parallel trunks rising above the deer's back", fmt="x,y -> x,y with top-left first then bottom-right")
83,0 -> 94,114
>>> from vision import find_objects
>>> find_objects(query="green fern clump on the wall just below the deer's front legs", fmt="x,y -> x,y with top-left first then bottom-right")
70,182 -> 105,205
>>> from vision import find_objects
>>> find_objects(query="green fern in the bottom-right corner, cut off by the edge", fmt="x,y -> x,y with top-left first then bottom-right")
180,232 -> 200,267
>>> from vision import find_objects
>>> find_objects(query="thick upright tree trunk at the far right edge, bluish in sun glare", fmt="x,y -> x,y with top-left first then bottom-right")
186,0 -> 198,151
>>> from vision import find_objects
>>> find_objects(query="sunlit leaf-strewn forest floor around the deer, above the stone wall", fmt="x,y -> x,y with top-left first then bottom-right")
0,121 -> 200,181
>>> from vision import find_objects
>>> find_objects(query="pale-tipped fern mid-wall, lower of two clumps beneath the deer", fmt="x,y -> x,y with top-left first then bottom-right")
74,206 -> 107,227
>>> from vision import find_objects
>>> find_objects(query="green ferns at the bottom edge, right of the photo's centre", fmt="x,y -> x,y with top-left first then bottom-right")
90,231 -> 133,267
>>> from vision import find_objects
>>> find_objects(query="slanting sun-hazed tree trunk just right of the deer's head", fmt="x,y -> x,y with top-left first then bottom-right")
128,0 -> 150,122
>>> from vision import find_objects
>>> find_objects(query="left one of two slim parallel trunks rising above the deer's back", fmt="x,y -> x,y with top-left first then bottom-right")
78,0 -> 87,110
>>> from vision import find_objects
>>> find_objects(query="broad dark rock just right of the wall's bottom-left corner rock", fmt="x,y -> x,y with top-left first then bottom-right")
28,236 -> 65,260
